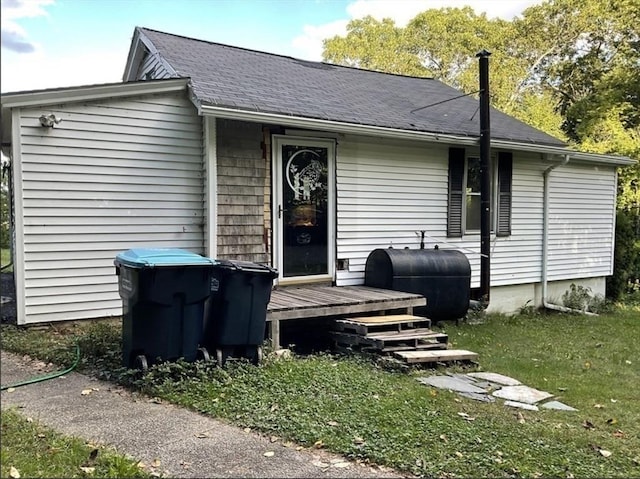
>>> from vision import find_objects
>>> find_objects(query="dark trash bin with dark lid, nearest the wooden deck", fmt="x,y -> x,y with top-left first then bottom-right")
202,260 -> 278,365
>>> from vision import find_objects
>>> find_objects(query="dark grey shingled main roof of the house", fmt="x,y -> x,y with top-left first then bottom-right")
131,27 -> 565,146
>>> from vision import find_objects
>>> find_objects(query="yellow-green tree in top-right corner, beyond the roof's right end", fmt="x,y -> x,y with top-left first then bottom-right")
524,0 -> 640,214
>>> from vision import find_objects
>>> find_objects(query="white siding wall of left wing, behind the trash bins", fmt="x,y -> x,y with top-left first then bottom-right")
14,94 -> 204,323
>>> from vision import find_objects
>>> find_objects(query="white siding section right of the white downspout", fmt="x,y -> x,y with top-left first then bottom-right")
548,163 -> 616,281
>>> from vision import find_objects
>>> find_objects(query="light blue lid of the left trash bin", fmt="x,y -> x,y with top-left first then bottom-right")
114,248 -> 216,268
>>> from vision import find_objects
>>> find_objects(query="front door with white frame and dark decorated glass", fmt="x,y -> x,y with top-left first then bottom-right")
273,136 -> 335,282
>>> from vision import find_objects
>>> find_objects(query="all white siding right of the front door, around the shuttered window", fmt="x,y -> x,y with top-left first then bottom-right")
336,137 -> 615,287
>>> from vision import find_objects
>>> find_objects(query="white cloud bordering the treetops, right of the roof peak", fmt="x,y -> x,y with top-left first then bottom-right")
292,0 -> 542,60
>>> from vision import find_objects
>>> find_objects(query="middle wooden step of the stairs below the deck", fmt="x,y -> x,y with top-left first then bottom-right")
330,329 -> 448,352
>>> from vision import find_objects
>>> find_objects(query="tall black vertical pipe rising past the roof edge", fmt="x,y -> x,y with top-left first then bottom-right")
476,50 -> 491,308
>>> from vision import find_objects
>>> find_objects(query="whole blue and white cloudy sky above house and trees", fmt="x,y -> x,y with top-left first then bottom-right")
0,0 -> 542,93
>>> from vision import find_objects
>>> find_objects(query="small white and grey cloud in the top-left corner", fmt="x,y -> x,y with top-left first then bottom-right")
0,0 -> 54,53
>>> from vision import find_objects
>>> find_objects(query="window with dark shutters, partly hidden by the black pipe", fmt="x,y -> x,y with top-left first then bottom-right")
447,148 -> 513,237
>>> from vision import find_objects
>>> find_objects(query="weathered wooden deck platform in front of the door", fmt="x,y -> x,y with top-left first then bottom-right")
267,285 -> 427,349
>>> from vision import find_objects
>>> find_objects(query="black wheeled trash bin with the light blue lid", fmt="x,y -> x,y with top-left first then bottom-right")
114,248 -> 215,369
